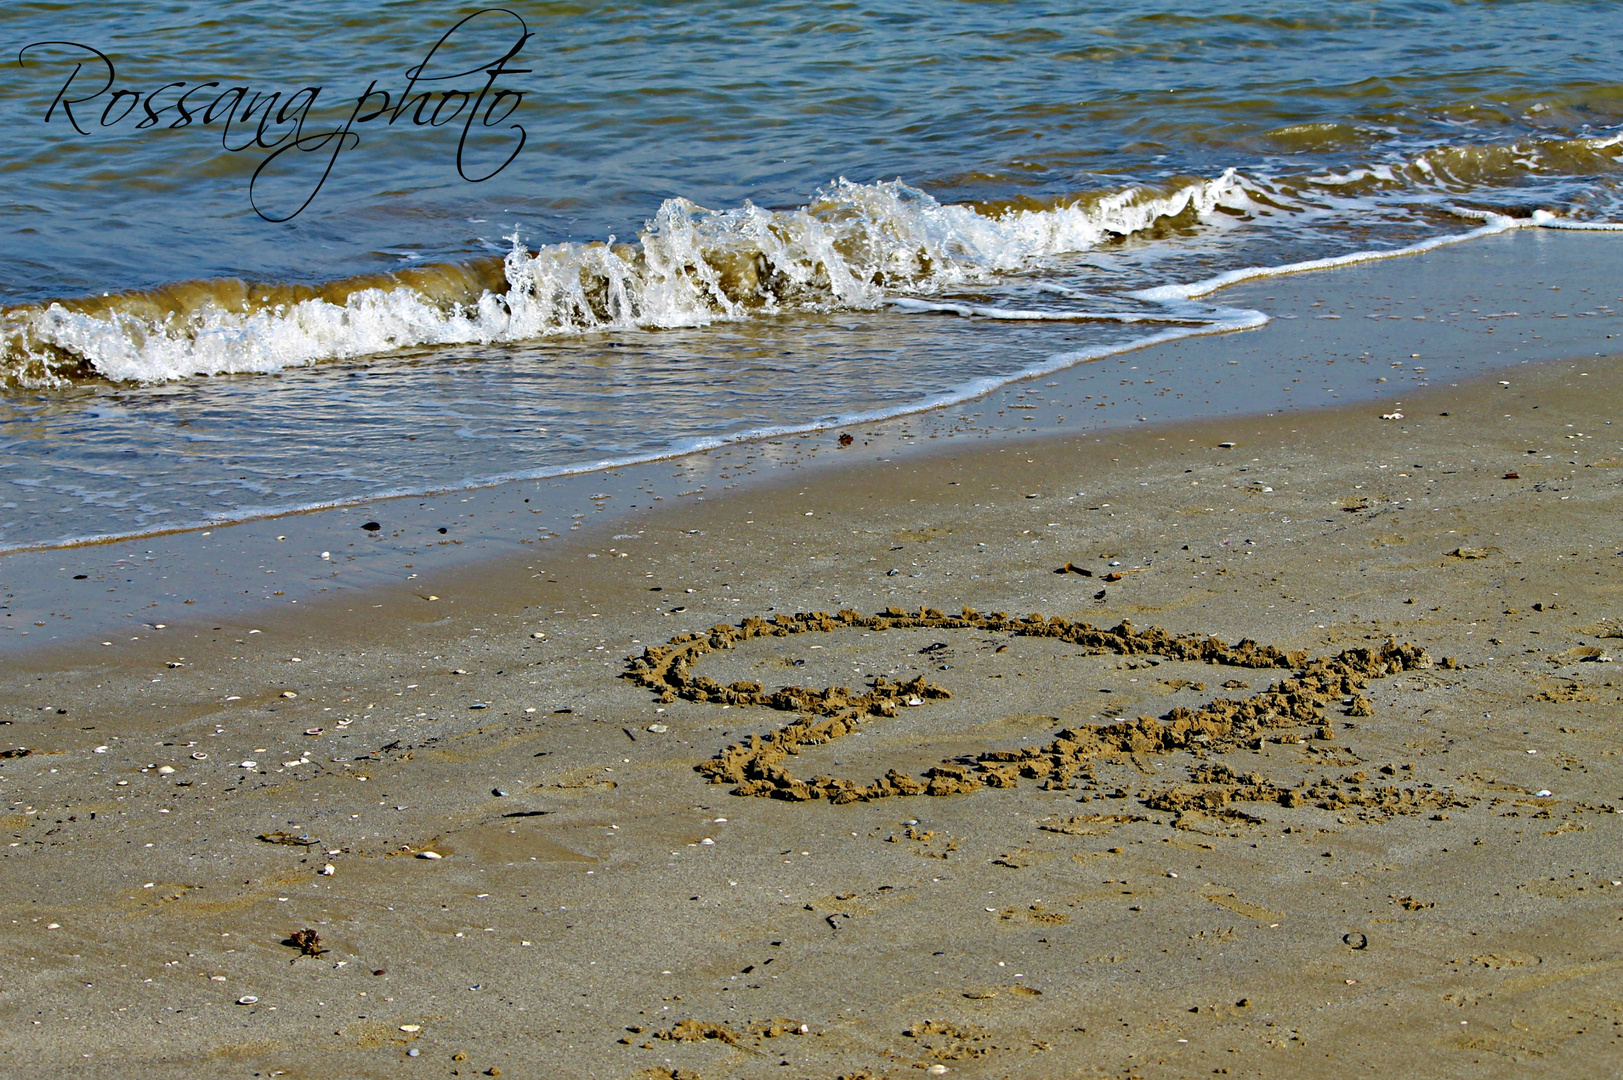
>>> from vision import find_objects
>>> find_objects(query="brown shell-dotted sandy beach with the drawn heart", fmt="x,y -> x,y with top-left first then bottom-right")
0,349 -> 1623,1078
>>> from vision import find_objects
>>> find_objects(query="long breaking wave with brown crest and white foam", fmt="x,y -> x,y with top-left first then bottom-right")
0,126 -> 1623,388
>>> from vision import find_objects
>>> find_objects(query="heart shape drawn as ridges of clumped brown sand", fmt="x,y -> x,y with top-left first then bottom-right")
623,607 -> 1464,817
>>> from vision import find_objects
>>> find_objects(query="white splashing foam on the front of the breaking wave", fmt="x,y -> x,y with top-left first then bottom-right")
0,171 -> 1251,383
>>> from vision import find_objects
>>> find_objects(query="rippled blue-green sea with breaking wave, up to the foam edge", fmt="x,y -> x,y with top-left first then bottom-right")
0,0 -> 1623,546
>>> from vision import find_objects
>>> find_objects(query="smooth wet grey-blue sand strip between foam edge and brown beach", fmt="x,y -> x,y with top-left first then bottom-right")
0,229 -> 1623,654
